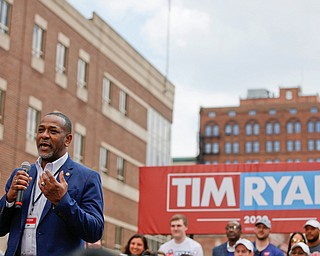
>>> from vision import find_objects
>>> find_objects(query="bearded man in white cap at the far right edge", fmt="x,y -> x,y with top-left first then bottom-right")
304,219 -> 320,253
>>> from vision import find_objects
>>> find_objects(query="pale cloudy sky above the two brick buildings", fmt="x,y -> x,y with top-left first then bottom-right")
68,0 -> 320,157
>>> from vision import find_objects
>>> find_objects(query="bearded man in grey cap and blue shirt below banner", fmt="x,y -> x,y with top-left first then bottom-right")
253,218 -> 283,256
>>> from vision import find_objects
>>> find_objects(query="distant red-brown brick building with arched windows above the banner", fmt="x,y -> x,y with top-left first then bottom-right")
197,87 -> 320,164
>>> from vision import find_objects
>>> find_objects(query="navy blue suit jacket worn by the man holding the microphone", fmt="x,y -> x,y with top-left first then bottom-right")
0,157 -> 104,256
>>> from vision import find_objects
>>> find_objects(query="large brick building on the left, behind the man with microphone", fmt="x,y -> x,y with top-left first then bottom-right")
0,0 -> 174,252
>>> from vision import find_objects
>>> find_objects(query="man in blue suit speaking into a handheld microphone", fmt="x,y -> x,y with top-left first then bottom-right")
0,112 -> 104,256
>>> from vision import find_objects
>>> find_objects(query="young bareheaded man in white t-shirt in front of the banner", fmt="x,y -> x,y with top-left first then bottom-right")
159,214 -> 203,256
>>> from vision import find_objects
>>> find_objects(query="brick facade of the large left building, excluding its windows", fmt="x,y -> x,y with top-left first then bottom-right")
0,0 -> 174,252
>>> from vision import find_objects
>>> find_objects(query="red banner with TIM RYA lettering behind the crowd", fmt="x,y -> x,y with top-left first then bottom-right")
138,163 -> 320,234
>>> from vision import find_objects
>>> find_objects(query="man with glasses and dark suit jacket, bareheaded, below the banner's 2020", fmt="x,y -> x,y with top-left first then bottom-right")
212,220 -> 241,256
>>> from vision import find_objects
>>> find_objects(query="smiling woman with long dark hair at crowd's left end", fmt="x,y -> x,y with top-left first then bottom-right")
123,234 -> 149,256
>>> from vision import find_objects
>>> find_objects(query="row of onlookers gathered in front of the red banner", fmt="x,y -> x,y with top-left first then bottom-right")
116,214 -> 320,256
